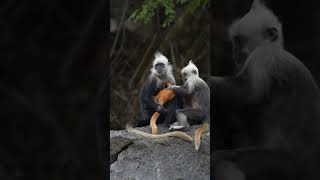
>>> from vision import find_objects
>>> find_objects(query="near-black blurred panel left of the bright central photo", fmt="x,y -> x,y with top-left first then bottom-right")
0,0 -> 108,180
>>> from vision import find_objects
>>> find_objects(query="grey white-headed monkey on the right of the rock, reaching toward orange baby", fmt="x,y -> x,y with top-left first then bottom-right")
167,60 -> 210,150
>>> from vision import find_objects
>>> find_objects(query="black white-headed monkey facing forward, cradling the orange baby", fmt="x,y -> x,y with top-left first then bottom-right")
134,51 -> 179,127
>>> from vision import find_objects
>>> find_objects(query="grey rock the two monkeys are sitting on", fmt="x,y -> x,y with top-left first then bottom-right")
110,126 -> 210,180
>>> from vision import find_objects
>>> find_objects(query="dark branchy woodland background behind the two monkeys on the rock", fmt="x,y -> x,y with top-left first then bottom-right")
108,0 -> 210,129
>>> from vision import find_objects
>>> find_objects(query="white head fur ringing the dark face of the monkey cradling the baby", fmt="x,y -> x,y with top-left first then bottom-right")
150,51 -> 176,84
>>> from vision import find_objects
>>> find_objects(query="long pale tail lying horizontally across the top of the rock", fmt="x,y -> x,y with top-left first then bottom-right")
126,124 -> 193,142
